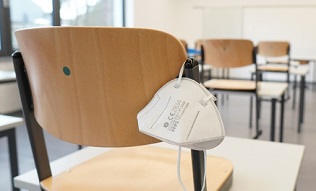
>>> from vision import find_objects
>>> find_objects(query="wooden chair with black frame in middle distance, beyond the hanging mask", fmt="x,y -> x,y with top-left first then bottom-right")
201,39 -> 261,138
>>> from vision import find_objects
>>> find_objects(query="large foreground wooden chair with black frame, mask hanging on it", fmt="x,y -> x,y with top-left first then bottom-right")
13,27 -> 232,191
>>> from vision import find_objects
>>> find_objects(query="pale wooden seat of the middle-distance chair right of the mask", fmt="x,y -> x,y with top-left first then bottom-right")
204,79 -> 256,91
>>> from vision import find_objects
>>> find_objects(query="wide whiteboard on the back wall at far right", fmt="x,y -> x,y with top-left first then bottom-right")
243,6 -> 316,81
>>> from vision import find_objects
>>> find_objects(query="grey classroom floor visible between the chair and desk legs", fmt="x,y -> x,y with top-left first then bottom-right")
0,84 -> 316,191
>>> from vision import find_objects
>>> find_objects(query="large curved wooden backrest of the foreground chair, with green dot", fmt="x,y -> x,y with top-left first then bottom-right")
15,27 -> 187,147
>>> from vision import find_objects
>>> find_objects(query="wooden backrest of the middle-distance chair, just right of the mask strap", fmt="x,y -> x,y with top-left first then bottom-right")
201,39 -> 256,68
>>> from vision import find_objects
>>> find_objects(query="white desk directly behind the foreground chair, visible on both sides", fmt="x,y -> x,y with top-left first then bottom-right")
14,137 -> 304,191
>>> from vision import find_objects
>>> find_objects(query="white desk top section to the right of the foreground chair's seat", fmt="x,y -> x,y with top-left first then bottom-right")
208,137 -> 304,191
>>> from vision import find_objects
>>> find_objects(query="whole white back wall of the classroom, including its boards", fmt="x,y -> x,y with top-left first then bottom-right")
134,0 -> 316,81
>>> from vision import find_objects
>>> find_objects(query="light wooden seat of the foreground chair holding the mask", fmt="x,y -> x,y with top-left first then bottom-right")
41,146 -> 233,191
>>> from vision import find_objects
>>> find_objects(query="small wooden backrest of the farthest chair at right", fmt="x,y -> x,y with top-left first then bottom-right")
257,41 -> 290,57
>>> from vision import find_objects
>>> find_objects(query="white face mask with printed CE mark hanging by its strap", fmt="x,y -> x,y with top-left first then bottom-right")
137,60 -> 225,190
